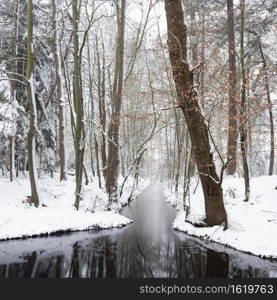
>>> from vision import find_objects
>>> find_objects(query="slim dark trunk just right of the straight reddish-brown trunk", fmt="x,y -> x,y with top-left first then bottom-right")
237,0 -> 250,201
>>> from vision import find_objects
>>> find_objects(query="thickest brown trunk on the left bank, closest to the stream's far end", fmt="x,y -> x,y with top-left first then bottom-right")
106,0 -> 126,205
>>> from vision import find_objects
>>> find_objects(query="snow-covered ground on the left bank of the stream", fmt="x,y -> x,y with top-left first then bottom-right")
0,176 -> 147,240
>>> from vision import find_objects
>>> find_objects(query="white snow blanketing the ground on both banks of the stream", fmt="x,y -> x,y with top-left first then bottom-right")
0,174 -> 277,259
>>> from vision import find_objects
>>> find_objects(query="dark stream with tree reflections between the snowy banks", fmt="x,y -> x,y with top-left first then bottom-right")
0,187 -> 277,278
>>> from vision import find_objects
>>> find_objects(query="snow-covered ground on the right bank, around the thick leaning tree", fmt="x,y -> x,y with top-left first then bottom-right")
163,176 -> 277,259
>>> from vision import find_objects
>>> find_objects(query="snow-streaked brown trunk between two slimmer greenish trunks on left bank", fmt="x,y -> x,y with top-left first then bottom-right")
52,0 -> 67,181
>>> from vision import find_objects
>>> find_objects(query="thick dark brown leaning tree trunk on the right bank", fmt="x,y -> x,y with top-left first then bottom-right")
165,0 -> 227,226
